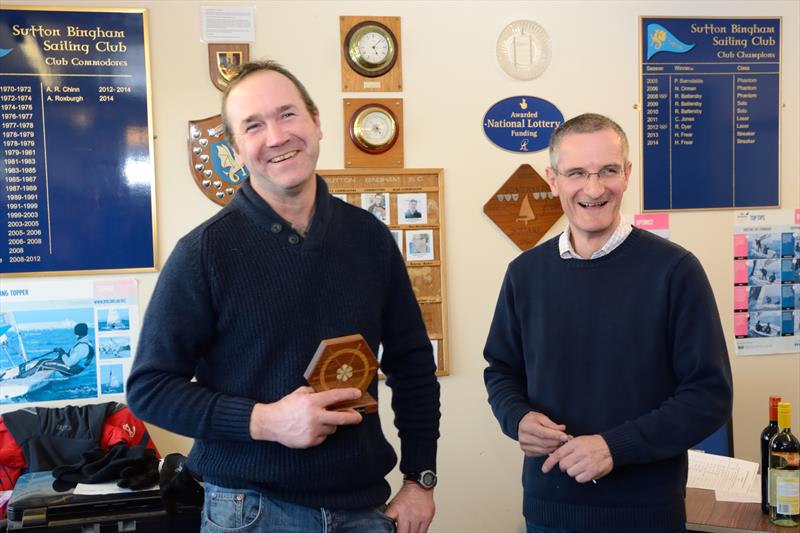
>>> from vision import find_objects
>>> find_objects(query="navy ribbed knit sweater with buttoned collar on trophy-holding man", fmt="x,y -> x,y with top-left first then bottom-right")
128,177 -> 439,508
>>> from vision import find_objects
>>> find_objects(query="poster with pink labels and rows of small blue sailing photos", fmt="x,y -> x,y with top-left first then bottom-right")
733,209 -> 800,355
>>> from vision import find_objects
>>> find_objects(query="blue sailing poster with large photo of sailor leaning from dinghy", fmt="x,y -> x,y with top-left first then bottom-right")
0,279 -> 139,411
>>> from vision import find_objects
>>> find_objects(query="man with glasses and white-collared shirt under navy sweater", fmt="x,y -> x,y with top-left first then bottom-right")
484,114 -> 732,533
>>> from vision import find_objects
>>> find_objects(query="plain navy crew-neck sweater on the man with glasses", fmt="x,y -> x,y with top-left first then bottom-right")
484,229 -> 732,533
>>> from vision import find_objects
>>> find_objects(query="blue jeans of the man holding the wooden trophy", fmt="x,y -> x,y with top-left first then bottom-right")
200,483 -> 395,533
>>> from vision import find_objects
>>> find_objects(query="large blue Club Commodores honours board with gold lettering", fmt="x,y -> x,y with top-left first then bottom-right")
0,7 -> 156,275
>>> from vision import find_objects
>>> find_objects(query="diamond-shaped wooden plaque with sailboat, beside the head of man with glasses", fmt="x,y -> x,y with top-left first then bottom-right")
483,164 -> 564,250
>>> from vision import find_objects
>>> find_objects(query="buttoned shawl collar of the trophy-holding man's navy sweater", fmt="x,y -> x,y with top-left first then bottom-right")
231,175 -> 333,252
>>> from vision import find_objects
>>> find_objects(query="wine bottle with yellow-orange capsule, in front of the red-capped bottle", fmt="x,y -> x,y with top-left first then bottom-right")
769,402 -> 800,527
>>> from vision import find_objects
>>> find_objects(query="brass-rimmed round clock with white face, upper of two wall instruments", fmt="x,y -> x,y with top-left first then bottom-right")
344,21 -> 397,78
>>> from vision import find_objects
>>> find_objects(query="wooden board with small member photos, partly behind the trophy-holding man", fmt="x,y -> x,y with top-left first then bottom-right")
318,169 -> 450,376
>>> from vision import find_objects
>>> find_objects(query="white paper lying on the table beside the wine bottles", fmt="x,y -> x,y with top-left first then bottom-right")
686,450 -> 760,490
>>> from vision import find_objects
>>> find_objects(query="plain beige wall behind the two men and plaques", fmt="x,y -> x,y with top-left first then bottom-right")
6,0 -> 800,533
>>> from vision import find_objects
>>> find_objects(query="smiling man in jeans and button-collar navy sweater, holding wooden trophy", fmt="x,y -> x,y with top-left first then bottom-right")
128,62 -> 439,533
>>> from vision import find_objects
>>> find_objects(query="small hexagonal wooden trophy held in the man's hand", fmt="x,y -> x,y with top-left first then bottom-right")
303,334 -> 378,414
